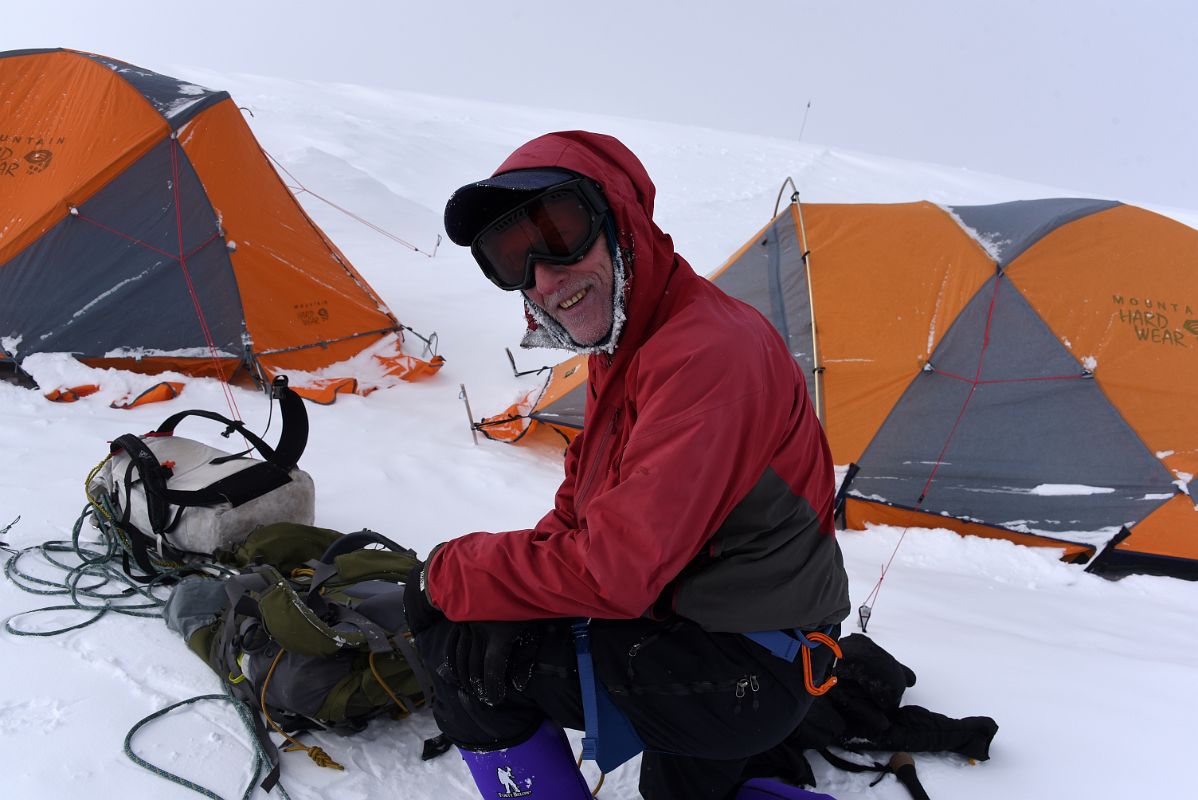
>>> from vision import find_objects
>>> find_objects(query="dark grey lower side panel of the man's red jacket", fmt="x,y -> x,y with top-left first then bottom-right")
673,467 -> 849,634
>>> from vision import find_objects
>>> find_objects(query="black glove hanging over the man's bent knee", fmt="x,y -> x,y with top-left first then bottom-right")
446,622 -> 540,705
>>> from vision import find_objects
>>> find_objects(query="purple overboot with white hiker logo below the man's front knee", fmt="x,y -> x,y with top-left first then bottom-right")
461,720 -> 591,800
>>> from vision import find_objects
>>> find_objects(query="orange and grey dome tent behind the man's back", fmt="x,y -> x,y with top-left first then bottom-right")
483,199 -> 1198,577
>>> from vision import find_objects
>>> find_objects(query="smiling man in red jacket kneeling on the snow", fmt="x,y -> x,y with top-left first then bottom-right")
405,132 -> 849,800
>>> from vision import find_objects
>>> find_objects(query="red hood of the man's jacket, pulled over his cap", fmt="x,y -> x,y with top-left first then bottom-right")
495,131 -> 691,360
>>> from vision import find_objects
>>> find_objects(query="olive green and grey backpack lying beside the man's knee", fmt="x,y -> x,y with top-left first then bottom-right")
164,522 -> 435,788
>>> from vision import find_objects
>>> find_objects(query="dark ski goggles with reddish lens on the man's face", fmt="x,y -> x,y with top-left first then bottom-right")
470,177 -> 607,291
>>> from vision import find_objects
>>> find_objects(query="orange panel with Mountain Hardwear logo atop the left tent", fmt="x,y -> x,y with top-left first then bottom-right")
0,51 -> 170,263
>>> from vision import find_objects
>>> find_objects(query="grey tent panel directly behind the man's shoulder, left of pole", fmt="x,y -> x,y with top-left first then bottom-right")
712,211 -> 816,398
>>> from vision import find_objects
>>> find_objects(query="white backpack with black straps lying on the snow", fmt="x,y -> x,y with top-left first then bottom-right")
87,376 -> 315,582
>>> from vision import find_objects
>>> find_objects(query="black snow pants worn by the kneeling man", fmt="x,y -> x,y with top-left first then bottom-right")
417,619 -> 839,800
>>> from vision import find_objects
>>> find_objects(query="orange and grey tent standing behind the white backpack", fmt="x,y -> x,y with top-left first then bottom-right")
0,49 -> 440,392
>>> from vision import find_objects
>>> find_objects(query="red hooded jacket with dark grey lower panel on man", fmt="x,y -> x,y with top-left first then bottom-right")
426,132 -> 848,632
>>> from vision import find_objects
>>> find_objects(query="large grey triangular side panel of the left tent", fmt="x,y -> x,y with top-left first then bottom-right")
0,140 -> 244,358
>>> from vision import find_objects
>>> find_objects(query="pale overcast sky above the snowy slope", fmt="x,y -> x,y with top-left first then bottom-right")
9,0 -> 1198,208
